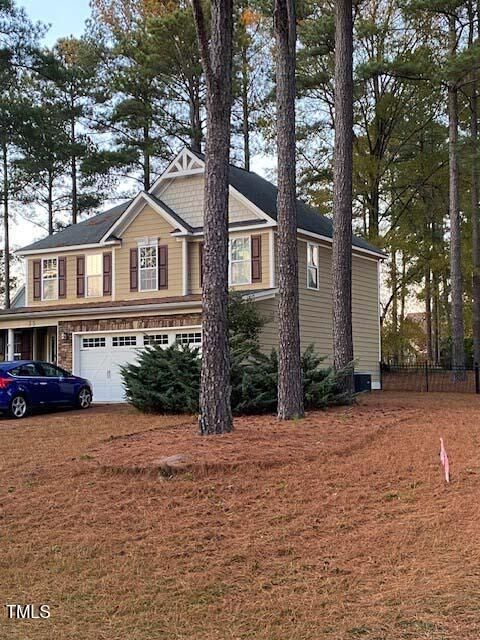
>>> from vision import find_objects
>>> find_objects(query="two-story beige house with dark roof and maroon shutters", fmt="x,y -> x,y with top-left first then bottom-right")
0,149 -> 383,401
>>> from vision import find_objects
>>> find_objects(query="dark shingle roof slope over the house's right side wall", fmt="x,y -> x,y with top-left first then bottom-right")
192,152 -> 383,255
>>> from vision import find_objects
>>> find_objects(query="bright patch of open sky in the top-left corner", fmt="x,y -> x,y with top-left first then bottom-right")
17,0 -> 90,46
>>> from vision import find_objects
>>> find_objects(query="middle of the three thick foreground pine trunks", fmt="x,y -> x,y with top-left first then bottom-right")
274,0 -> 304,420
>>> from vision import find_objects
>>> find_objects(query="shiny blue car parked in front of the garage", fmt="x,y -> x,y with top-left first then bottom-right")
0,360 -> 93,418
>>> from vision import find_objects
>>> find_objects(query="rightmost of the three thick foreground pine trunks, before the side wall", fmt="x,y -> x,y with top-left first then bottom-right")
332,0 -> 353,391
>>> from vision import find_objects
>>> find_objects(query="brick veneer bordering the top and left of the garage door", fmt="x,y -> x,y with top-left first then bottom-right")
58,313 -> 201,370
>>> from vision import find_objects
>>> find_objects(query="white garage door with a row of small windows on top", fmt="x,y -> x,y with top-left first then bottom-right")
73,327 -> 202,402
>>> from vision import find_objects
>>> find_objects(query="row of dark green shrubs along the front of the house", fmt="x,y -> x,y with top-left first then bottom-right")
121,294 -> 352,415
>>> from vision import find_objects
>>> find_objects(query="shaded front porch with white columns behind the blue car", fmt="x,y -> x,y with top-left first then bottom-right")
0,326 -> 57,364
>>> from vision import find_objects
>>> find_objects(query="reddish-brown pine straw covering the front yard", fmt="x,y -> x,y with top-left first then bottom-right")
0,393 -> 480,640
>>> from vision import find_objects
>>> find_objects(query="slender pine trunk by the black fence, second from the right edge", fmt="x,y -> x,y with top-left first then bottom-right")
448,16 -> 465,369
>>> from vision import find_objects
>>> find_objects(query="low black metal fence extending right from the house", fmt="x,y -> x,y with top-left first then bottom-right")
380,362 -> 480,393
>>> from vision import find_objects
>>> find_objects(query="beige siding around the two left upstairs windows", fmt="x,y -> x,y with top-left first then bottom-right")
27,247 -> 115,307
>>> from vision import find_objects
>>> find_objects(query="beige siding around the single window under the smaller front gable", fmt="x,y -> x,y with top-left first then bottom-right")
115,206 -> 183,300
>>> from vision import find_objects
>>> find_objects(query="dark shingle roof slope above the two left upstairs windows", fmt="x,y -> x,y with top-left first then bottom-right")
21,200 -> 131,251
